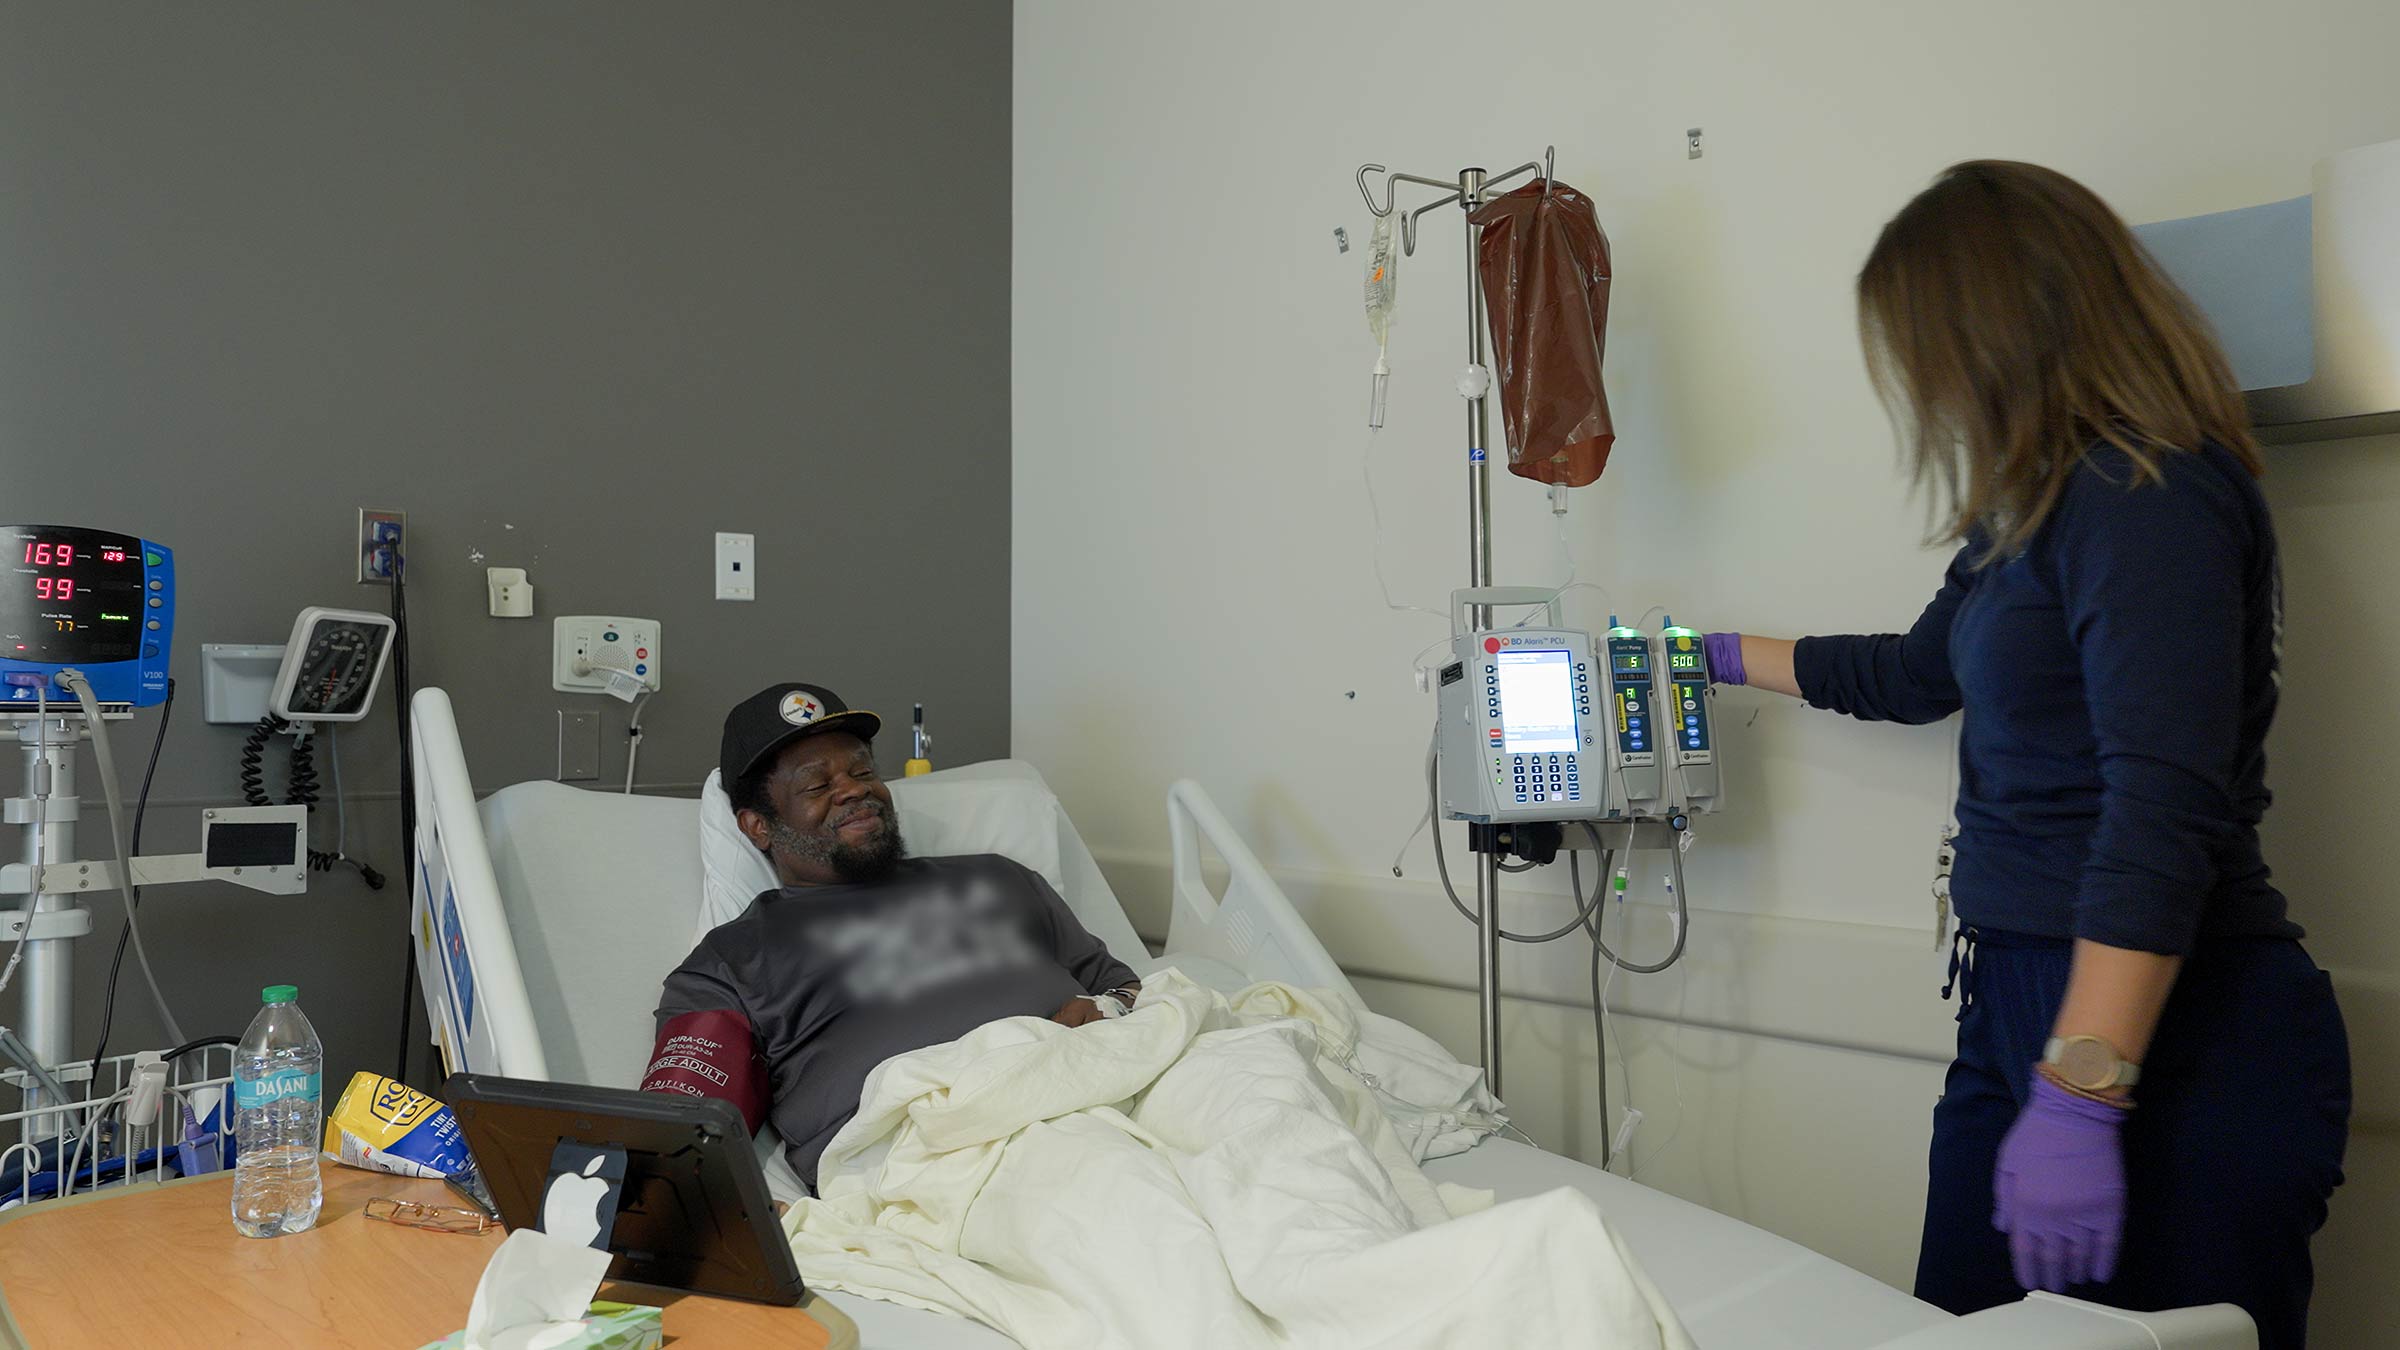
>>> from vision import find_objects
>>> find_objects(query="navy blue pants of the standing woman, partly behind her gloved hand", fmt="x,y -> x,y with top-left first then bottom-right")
1918,930 -> 2350,1350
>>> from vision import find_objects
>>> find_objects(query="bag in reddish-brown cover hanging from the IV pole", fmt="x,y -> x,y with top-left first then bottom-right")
1469,178 -> 1618,488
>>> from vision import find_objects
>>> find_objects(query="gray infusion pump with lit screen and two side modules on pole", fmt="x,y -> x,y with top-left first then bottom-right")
1438,586 -> 1718,824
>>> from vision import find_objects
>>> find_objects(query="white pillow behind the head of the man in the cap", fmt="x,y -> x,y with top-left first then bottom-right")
691,769 -> 1066,942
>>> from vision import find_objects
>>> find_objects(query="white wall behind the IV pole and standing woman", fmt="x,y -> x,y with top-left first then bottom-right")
1013,0 -> 2400,1345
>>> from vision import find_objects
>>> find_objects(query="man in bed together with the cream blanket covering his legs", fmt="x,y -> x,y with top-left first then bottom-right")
643,685 -> 1690,1350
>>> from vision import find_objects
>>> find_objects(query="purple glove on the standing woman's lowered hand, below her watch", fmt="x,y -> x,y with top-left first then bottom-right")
1992,1076 -> 2129,1295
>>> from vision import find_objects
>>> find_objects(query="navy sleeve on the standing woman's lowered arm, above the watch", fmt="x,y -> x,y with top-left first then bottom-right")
2057,454 -> 2268,956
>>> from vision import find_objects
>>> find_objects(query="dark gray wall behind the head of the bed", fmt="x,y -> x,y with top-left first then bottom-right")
0,0 -> 1010,1079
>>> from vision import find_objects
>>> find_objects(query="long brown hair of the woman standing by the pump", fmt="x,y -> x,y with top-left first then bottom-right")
1858,159 -> 2263,560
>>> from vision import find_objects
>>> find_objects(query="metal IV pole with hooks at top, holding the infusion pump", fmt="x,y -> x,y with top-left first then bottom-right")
1358,147 -> 1558,1098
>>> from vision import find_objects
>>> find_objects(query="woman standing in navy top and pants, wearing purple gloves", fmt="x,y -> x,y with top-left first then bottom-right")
1706,161 -> 2350,1350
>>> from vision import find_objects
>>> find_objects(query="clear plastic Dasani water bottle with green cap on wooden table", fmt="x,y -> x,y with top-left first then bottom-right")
233,985 -> 324,1237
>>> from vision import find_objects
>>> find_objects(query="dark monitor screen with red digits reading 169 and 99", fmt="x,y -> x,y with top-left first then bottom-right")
0,526 -> 146,665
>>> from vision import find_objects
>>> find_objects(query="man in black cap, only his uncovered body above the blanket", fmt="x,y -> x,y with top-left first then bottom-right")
641,685 -> 1140,1189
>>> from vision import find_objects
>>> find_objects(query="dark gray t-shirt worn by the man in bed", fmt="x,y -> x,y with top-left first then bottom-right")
658,853 -> 1133,1191
